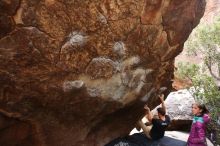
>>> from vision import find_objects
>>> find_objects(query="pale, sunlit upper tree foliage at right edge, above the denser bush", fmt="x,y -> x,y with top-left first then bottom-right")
185,17 -> 220,81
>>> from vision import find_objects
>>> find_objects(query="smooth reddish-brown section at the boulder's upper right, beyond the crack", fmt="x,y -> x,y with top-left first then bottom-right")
163,0 -> 205,48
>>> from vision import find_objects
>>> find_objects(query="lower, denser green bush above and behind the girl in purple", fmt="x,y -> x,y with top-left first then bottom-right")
175,62 -> 220,120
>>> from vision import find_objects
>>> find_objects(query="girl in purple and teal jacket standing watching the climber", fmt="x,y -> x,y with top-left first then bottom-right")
187,103 -> 210,146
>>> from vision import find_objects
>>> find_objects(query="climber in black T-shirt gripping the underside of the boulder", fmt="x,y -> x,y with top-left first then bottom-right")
137,94 -> 170,140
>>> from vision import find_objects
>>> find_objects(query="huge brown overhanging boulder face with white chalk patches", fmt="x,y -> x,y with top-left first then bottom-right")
0,0 -> 205,146
